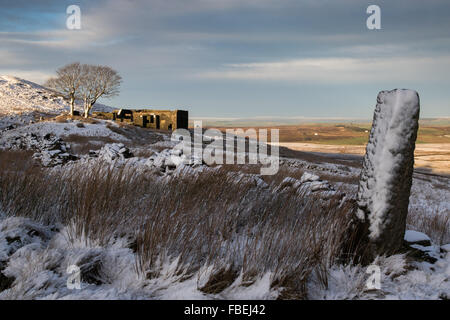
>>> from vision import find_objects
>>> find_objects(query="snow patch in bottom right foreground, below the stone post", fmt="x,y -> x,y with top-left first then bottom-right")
310,253 -> 450,300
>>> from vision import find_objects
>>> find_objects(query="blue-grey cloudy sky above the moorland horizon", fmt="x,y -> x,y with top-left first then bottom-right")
0,0 -> 450,118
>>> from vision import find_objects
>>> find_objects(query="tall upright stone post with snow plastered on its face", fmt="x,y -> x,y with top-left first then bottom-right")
356,89 -> 420,261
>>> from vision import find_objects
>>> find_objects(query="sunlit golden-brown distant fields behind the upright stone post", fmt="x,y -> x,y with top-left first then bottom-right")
202,119 -> 450,174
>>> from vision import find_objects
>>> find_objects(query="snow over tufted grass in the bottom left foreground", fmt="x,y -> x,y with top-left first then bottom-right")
0,218 -> 282,300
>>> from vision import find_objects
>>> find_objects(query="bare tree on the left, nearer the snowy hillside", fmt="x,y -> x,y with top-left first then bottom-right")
45,62 -> 83,116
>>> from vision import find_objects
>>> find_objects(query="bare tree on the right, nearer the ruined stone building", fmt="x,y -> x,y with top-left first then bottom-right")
80,65 -> 122,118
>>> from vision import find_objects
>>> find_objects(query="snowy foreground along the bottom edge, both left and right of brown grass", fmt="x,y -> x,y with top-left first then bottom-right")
0,217 -> 450,299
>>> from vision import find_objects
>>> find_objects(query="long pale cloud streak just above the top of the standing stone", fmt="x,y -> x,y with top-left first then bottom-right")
196,56 -> 450,84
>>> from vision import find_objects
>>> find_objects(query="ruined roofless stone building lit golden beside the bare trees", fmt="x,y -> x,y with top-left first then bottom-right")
93,109 -> 189,130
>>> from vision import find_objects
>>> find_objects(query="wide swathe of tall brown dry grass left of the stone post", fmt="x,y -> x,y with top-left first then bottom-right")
0,152 -> 358,299
